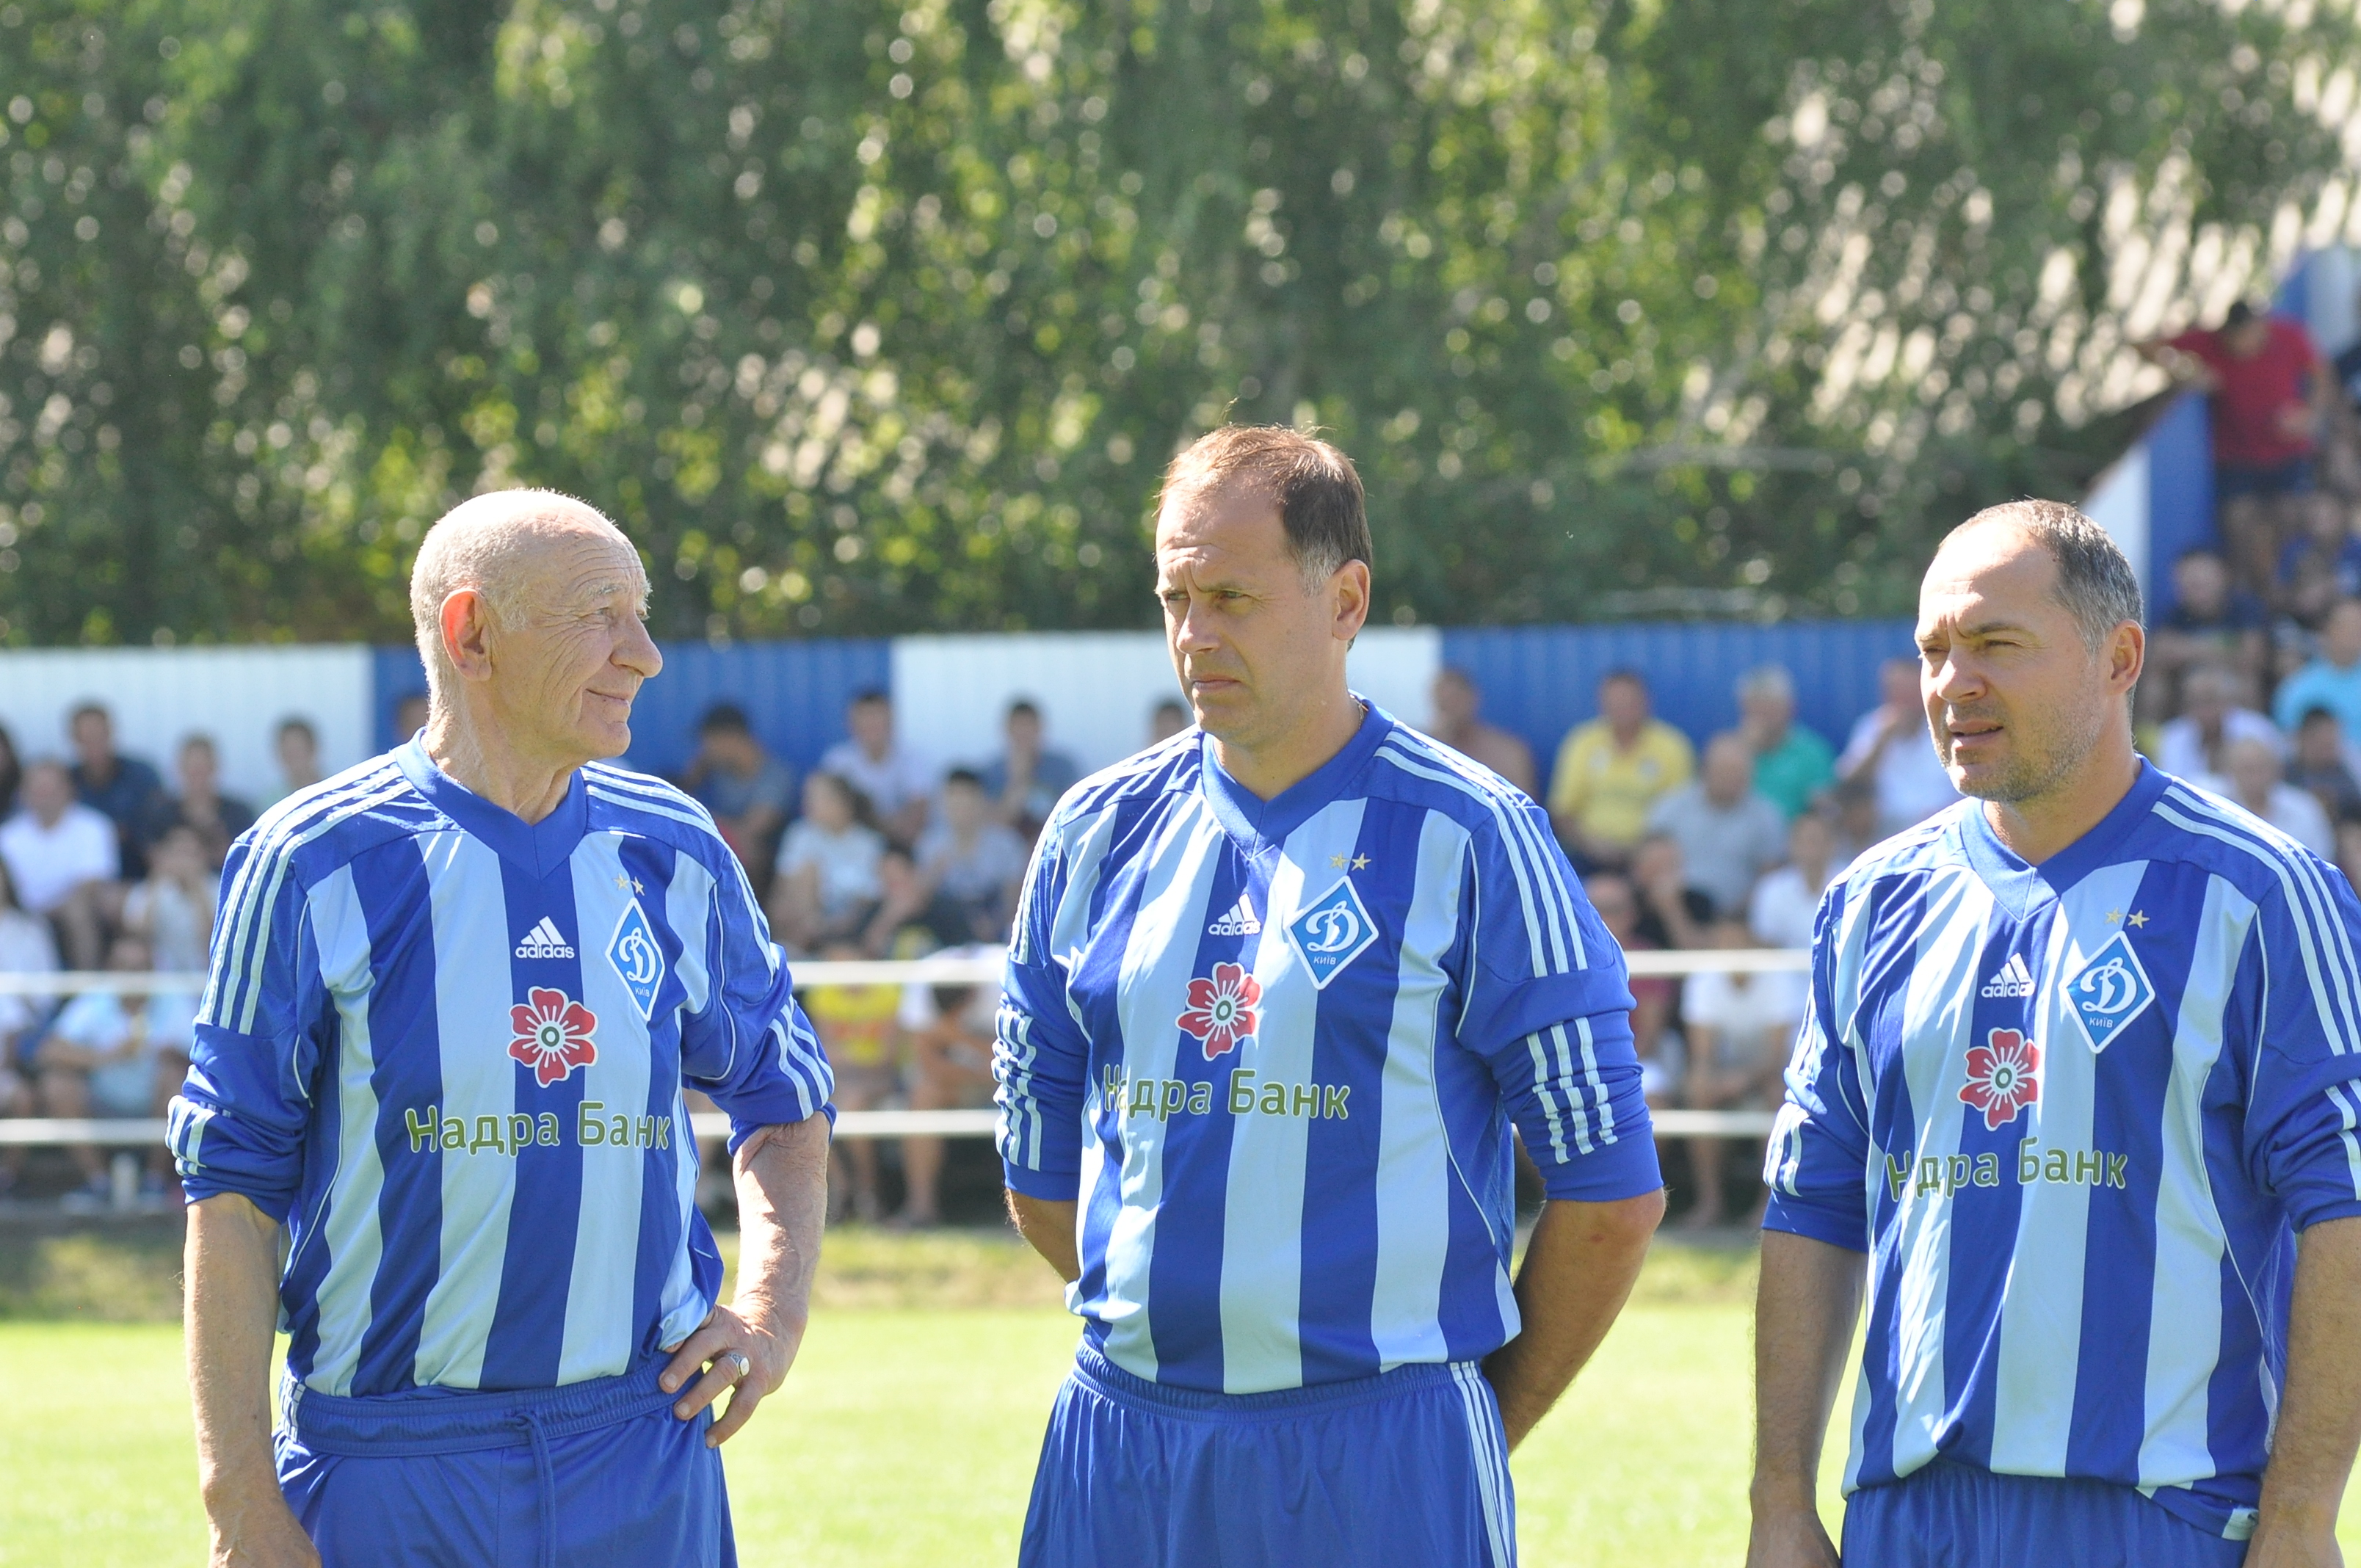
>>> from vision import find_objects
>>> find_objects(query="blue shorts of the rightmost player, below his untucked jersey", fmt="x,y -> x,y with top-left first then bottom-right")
1844,1459 -> 2245,1568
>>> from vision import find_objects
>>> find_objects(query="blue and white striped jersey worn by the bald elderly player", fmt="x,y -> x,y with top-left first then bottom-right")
170,741 -> 831,1395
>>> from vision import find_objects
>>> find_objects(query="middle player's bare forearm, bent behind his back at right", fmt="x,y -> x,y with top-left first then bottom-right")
1483,1193 -> 1664,1448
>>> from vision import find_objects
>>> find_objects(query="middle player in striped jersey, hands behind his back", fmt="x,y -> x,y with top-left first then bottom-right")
994,427 -> 1664,1568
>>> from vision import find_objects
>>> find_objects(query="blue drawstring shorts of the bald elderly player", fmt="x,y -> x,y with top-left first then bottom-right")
278,1360 -> 736,1568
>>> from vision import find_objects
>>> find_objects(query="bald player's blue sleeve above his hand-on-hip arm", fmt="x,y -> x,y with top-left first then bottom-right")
680,838 -> 835,1155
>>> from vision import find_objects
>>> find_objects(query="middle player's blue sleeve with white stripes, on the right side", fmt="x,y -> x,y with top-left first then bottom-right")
1457,801 -> 1664,1202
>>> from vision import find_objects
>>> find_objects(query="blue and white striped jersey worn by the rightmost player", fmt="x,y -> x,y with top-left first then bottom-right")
1766,767 -> 2361,1537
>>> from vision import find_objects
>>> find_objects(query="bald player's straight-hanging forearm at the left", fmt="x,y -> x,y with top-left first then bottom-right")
182,1193 -> 302,1539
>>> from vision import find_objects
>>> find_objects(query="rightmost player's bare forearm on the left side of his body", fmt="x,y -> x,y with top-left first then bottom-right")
1754,1230 -> 1868,1516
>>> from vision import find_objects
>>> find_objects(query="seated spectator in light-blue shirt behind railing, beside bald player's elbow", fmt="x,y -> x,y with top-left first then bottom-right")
33,935 -> 196,1209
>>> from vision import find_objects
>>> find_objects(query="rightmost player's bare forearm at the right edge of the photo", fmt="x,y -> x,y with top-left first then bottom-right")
2255,1219 -> 2361,1564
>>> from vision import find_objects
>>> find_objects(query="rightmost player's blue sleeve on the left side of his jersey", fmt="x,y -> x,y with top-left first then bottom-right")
1763,881 -> 1870,1252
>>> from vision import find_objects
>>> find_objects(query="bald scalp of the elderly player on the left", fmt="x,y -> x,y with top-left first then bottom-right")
411,489 -> 647,708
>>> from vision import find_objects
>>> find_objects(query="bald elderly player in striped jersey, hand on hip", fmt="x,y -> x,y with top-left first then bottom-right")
170,491 -> 831,1568
